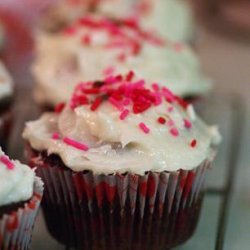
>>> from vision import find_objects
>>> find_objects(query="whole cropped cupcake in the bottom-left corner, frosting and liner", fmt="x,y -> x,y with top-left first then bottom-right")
0,149 -> 43,250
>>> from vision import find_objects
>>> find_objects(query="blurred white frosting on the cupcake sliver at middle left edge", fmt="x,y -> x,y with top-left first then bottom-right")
0,61 -> 13,99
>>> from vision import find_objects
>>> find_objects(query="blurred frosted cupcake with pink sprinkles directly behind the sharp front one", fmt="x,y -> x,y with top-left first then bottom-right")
32,15 -> 211,107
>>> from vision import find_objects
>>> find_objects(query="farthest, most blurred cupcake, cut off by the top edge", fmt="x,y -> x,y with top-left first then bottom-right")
39,0 -> 194,42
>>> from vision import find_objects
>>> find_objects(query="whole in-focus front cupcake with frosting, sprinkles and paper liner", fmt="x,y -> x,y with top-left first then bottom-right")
23,71 -> 219,250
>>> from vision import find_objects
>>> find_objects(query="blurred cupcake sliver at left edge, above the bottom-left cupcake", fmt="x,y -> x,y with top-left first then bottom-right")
0,61 -> 13,148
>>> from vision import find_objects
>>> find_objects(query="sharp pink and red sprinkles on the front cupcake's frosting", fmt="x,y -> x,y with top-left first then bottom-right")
52,71 -> 197,151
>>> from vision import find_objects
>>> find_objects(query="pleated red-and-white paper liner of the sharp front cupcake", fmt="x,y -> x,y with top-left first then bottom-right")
30,149 -> 210,250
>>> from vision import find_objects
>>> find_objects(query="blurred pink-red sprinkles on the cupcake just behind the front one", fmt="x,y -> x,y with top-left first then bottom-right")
64,16 -> 166,61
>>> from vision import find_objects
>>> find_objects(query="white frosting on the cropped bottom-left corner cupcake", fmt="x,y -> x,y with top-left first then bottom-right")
0,149 -> 35,206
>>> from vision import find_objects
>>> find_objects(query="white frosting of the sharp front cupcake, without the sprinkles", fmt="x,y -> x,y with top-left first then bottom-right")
23,79 -> 218,175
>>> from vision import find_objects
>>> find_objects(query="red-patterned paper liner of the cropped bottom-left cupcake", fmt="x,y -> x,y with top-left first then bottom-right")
0,178 -> 43,250
